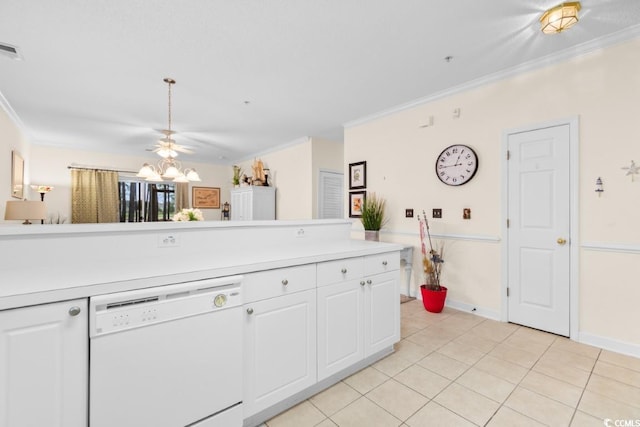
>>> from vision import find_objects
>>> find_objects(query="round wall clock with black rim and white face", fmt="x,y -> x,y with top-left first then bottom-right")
436,145 -> 478,185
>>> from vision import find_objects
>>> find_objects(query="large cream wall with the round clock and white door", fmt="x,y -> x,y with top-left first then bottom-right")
345,39 -> 640,354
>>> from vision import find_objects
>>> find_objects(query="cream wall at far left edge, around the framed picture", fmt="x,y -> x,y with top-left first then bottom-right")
0,106 -> 31,223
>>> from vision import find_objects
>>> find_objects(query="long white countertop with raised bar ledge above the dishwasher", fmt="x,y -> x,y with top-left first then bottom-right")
0,220 -> 402,309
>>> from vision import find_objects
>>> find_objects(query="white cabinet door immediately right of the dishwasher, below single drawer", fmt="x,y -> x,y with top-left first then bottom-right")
243,290 -> 317,418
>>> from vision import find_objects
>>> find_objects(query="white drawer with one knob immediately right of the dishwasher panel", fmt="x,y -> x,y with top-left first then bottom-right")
242,264 -> 316,304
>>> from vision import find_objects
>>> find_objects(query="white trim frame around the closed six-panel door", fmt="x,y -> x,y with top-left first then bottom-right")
500,116 -> 580,340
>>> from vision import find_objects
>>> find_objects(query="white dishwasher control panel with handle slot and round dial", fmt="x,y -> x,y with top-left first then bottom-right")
89,276 -> 242,337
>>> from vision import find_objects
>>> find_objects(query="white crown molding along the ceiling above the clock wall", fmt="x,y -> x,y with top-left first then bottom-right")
343,25 -> 640,129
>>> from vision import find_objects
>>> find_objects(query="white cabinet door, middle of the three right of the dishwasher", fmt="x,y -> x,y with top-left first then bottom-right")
317,279 -> 365,381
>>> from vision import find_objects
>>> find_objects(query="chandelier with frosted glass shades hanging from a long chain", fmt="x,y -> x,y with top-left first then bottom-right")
136,77 -> 200,182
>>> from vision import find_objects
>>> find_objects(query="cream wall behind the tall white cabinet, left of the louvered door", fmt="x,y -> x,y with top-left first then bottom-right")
231,138 -> 313,219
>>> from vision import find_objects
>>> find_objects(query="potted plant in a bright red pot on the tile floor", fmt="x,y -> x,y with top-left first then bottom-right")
418,211 -> 447,313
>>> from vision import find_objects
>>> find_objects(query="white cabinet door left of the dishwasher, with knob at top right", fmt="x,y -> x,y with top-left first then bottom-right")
0,299 -> 89,427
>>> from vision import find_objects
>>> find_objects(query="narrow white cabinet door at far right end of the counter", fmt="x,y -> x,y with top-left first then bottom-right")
364,271 -> 400,357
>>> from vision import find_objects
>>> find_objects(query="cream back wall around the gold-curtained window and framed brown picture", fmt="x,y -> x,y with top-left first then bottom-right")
30,145 -> 232,222
